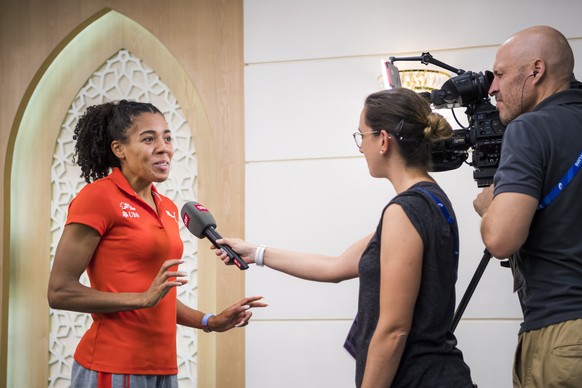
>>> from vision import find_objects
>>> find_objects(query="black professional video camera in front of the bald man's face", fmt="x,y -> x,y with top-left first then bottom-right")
385,53 -> 505,187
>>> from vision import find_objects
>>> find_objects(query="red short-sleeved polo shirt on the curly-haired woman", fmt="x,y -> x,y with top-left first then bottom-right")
67,168 -> 183,374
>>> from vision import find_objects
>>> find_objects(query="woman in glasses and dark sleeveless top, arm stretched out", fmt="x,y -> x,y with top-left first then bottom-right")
216,89 -> 472,388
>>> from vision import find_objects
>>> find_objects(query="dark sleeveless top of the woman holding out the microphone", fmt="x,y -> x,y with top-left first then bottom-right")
355,182 -> 472,388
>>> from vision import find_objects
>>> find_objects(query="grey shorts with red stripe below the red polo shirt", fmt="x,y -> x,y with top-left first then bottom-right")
71,361 -> 178,388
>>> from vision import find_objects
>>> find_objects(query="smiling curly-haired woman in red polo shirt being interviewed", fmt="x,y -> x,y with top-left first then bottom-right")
48,100 -> 266,388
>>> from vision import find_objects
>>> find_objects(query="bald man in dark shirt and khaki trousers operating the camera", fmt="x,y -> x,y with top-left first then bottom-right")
473,26 -> 582,387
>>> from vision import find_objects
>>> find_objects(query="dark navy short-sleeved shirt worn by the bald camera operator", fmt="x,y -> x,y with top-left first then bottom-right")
494,90 -> 582,332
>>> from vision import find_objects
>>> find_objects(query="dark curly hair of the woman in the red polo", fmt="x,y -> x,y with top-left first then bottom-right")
73,100 -> 162,183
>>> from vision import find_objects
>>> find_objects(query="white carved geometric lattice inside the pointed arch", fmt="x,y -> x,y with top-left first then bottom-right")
48,49 -> 198,388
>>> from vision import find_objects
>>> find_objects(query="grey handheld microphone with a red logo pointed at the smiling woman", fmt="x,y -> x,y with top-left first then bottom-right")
180,201 -> 249,271
